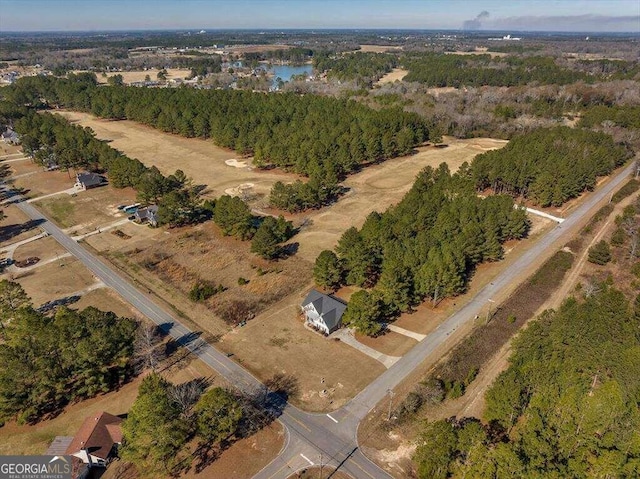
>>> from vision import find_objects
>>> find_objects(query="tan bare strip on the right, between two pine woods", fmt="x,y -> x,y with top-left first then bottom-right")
296,138 -> 507,261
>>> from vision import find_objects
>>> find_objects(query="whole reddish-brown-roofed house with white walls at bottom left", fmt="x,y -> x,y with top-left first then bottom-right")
65,412 -> 122,467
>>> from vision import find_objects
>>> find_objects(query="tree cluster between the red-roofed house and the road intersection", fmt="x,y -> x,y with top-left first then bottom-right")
118,373 -> 290,477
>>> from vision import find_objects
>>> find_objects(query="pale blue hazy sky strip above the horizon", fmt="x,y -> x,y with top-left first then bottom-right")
0,0 -> 640,33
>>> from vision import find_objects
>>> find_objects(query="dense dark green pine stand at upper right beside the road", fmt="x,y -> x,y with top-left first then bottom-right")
471,127 -> 630,206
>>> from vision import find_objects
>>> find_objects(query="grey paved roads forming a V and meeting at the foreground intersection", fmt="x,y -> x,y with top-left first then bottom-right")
5,163 -> 635,479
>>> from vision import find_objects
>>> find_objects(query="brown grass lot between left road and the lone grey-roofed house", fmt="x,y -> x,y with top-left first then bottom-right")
86,223 -> 384,410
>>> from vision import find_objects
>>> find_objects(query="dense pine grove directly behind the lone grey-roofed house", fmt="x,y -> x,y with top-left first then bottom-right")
314,163 -> 529,334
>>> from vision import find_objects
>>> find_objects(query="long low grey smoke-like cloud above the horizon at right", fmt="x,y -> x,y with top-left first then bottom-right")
488,14 -> 640,32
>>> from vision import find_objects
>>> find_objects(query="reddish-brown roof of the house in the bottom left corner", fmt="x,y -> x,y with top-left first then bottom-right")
66,412 -> 122,459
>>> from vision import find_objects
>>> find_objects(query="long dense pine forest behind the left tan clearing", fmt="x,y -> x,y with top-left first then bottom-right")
6,75 -> 428,176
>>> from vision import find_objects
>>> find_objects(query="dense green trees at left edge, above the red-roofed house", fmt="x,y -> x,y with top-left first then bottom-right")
0,280 -> 137,423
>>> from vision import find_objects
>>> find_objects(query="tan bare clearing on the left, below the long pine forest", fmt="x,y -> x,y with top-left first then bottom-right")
60,111 -> 294,202
